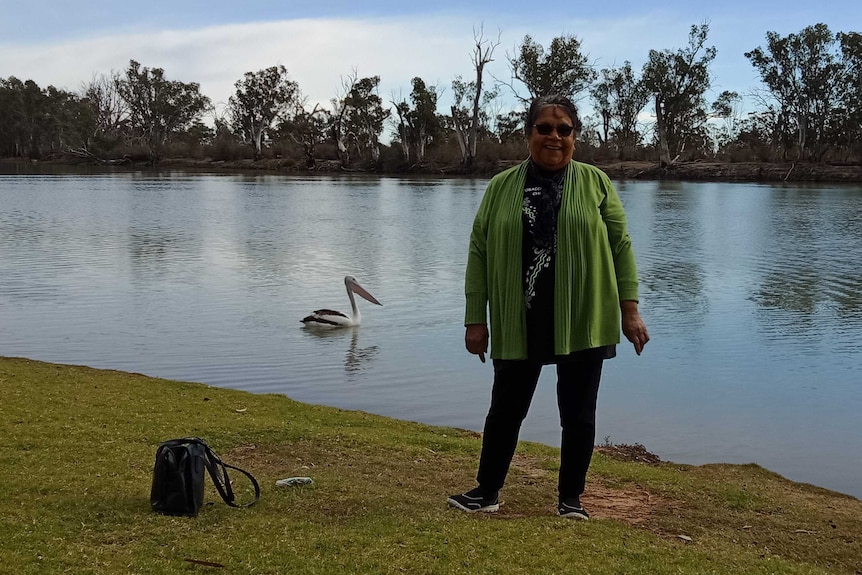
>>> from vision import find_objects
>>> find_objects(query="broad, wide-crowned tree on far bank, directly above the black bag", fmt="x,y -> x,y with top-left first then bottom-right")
117,60 -> 210,162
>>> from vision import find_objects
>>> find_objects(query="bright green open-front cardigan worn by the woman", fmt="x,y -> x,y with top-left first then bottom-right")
464,160 -> 638,359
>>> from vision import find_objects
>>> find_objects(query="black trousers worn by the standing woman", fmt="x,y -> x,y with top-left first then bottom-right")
476,356 -> 603,499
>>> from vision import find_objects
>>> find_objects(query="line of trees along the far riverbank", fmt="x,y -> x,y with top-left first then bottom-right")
0,24 -> 862,172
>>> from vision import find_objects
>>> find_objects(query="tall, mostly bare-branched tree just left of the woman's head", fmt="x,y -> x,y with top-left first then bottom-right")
450,28 -> 500,172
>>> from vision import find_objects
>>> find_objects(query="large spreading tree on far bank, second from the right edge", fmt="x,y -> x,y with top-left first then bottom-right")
745,24 -> 844,160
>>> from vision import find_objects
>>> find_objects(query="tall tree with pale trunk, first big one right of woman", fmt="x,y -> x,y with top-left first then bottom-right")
643,23 -> 716,165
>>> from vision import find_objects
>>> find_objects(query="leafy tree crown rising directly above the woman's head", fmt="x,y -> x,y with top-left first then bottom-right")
507,35 -> 596,103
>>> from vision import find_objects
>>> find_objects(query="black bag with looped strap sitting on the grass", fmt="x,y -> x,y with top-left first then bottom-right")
150,437 -> 260,517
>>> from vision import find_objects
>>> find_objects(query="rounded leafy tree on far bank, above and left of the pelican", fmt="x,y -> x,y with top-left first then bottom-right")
228,65 -> 299,160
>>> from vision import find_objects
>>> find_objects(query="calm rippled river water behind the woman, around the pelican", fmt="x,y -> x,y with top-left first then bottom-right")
0,166 -> 862,497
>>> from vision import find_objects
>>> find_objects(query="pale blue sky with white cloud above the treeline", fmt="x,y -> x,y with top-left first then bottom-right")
0,0 -> 862,121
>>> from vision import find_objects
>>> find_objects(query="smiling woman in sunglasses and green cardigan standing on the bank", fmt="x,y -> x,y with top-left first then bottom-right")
448,96 -> 649,519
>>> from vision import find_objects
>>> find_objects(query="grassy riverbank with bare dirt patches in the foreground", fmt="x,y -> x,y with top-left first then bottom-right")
0,358 -> 862,575
